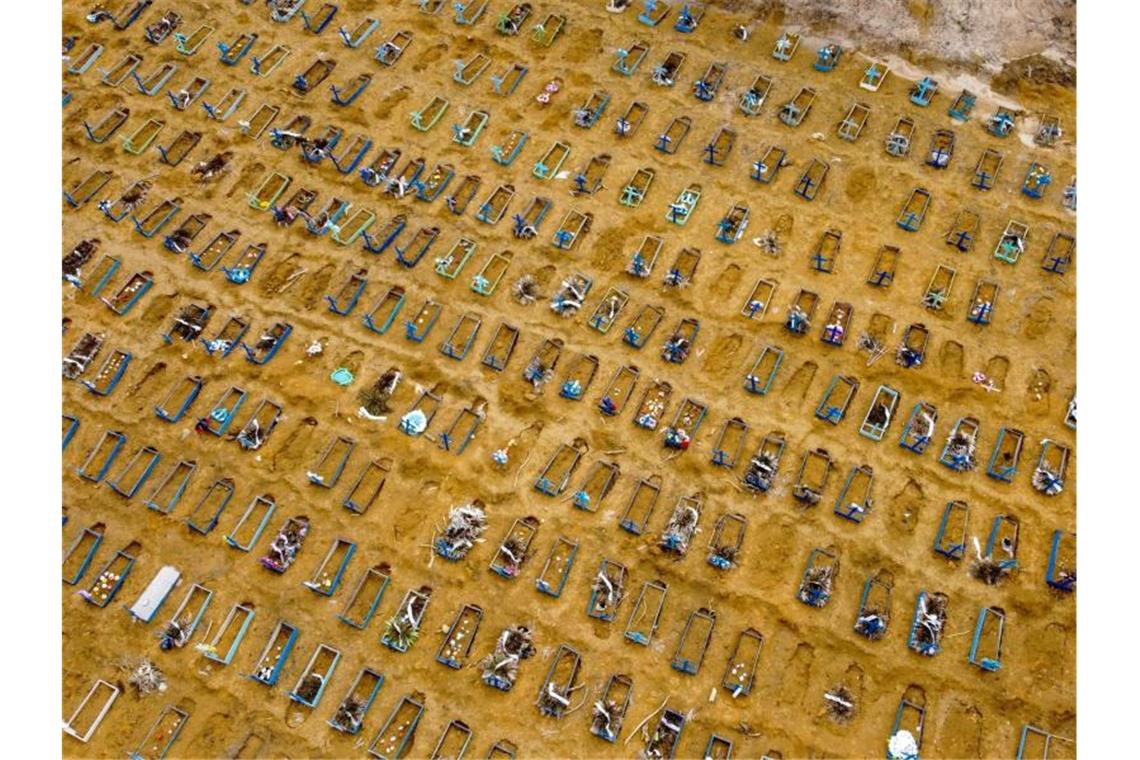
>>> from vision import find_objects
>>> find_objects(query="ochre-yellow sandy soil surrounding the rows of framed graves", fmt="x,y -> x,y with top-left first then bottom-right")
60,0 -> 1076,758
